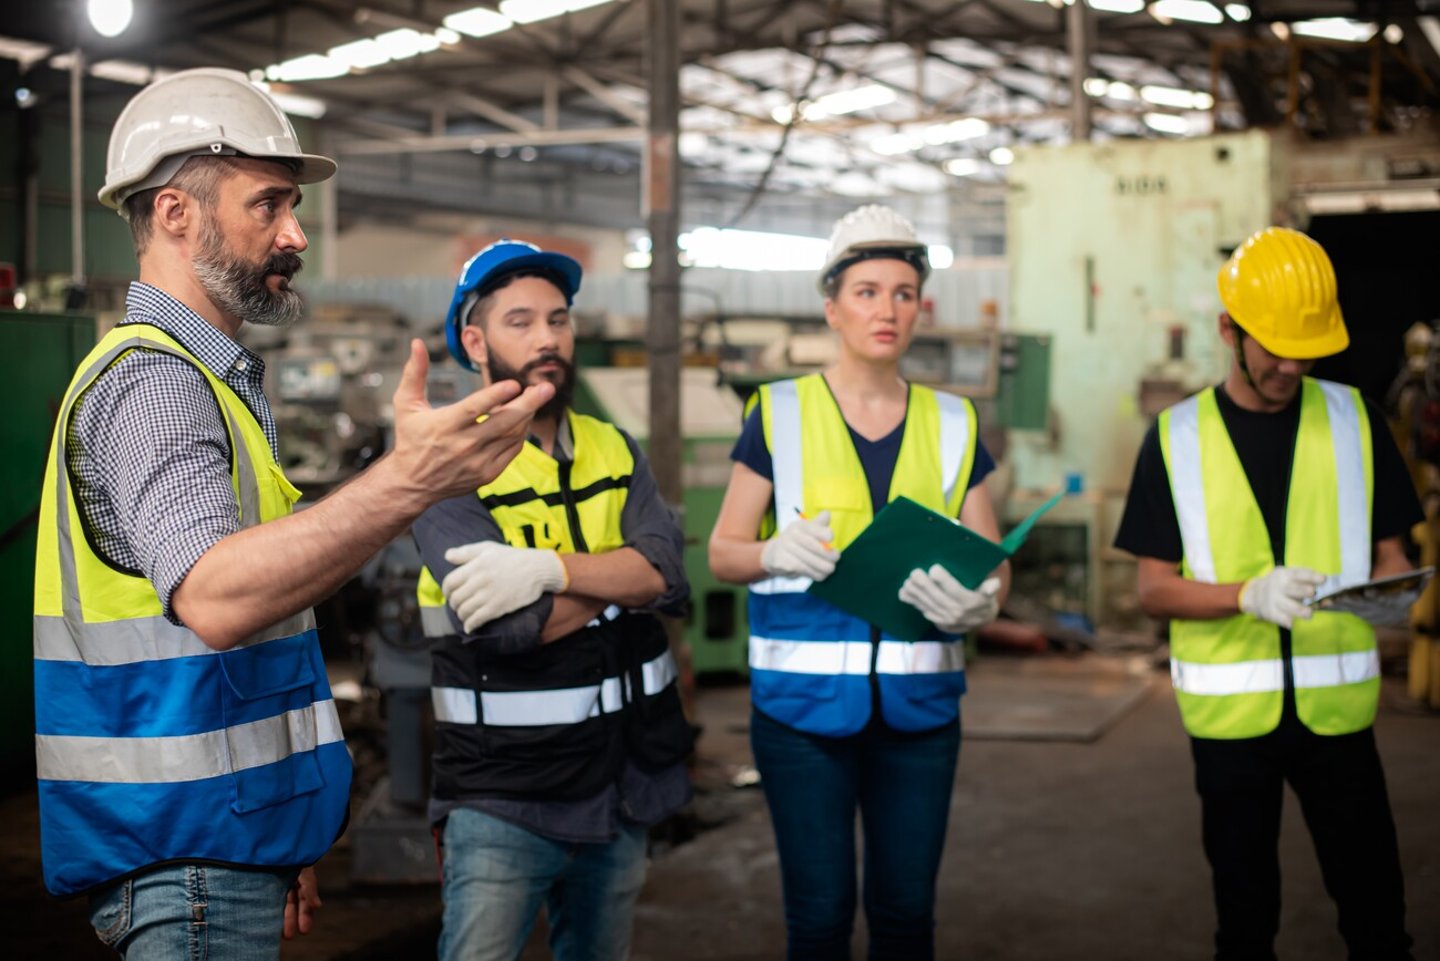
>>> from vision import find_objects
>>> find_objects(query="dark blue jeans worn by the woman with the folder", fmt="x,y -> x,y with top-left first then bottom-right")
750,712 -> 960,961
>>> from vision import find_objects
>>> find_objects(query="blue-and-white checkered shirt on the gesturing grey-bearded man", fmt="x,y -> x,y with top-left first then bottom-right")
65,282 -> 278,622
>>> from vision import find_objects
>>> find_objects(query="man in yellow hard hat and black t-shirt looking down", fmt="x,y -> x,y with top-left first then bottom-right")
1116,228 -> 1421,961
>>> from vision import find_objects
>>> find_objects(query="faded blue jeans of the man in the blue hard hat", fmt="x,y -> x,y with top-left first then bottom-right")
439,808 -> 649,961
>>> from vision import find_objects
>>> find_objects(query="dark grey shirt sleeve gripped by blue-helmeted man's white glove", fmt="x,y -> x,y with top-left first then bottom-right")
410,494 -> 554,654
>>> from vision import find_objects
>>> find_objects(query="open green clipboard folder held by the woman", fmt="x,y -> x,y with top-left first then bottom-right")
809,491 -> 1064,641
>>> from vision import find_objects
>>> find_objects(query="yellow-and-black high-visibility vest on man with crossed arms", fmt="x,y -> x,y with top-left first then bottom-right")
416,412 -> 693,801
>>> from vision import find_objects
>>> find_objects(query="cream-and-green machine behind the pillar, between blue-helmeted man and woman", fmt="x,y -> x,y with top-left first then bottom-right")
575,363 -> 749,676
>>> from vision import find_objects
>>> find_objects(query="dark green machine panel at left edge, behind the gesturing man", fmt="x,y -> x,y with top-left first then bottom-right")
0,311 -> 95,785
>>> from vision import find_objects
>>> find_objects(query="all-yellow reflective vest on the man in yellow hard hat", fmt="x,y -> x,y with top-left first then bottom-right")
1158,377 -> 1380,739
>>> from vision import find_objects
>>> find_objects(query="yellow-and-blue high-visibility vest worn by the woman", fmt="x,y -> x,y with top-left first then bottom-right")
749,375 -> 976,736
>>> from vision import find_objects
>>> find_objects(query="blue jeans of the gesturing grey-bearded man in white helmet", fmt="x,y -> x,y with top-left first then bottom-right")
89,864 -> 298,961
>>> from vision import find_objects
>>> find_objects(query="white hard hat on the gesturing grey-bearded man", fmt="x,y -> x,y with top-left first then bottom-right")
99,66 -> 336,216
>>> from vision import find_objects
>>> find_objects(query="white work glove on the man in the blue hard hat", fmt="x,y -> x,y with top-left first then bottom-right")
441,540 -> 570,633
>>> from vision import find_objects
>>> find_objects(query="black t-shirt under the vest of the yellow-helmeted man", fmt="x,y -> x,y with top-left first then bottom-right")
1115,386 -> 1424,563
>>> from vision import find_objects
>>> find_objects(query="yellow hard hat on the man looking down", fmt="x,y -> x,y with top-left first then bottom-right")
1220,226 -> 1349,360
